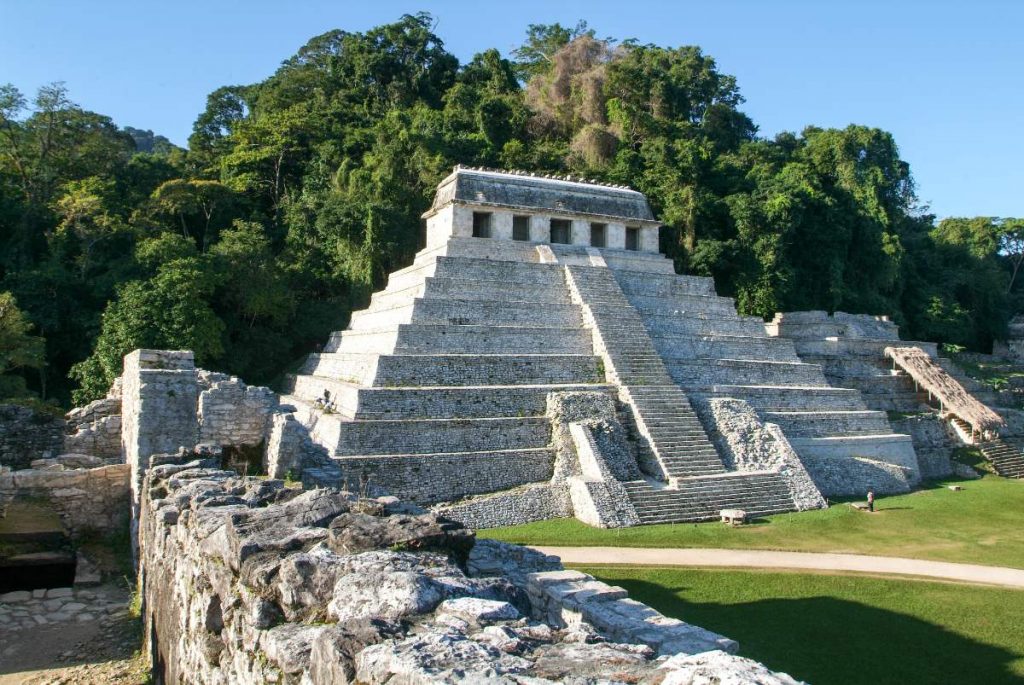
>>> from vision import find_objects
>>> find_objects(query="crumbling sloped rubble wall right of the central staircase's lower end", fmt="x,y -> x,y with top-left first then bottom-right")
692,397 -> 828,511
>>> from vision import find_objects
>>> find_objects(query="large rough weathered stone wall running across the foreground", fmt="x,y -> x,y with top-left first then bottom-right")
140,455 -> 795,685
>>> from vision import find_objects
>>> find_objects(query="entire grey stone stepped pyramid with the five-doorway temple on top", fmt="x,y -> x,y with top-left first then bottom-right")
278,167 -> 920,527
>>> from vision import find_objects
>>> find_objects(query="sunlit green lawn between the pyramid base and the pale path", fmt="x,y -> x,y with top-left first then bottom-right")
479,476 -> 1024,568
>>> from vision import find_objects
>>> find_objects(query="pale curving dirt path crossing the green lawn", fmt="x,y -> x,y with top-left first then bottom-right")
535,547 -> 1024,589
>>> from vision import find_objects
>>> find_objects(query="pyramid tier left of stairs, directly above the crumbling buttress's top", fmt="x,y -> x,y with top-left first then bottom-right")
301,352 -> 604,387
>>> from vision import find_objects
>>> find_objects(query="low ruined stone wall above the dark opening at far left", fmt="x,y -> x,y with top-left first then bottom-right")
0,456 -> 130,538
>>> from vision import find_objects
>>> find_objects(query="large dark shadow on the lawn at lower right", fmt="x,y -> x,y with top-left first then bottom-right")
613,579 -> 1024,685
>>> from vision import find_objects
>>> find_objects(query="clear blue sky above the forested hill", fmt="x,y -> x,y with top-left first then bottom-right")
0,0 -> 1024,216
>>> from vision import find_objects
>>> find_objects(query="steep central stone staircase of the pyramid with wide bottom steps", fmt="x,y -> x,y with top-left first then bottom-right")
565,265 -> 794,523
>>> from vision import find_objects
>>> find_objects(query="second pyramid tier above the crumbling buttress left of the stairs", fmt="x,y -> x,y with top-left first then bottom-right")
324,324 -> 594,354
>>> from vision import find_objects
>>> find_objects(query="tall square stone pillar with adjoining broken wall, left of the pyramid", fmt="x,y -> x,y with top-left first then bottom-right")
121,349 -> 199,552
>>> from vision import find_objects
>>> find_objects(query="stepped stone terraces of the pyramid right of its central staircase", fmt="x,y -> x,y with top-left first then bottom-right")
615,272 -> 916,485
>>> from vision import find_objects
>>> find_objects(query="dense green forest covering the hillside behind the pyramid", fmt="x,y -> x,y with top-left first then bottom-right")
0,14 -> 1024,401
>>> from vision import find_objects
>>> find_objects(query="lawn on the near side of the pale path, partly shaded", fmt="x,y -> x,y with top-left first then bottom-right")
581,566 -> 1024,685
